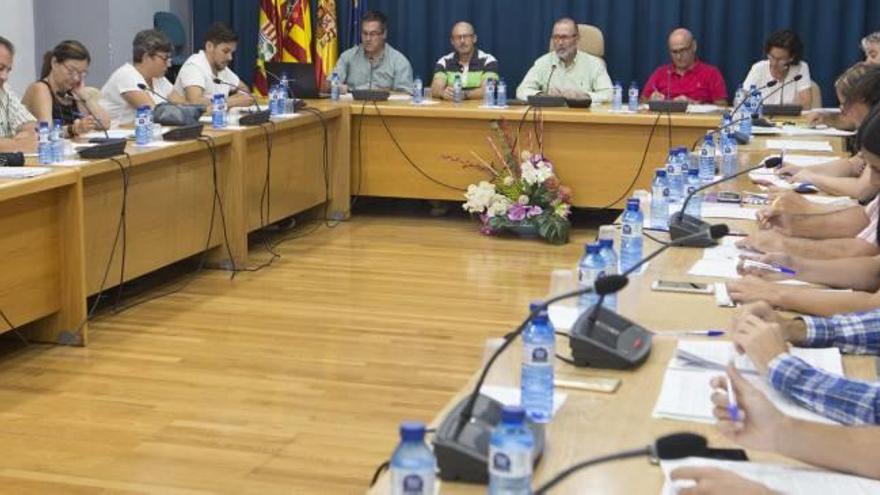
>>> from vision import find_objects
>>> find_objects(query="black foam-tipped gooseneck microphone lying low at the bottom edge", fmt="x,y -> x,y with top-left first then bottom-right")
534,433 -> 708,495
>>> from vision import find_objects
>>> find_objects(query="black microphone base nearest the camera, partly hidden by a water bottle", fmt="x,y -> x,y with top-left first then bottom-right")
433,395 -> 544,485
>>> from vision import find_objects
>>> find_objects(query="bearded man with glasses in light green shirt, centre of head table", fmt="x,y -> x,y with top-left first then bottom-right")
516,17 -> 612,103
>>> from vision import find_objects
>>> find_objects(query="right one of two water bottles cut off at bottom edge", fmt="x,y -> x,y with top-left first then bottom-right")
489,406 -> 535,495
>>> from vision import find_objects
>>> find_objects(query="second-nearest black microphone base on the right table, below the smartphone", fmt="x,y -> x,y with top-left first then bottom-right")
568,306 -> 654,370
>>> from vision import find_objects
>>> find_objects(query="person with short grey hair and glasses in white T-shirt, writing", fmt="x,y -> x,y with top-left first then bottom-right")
101,29 -> 186,126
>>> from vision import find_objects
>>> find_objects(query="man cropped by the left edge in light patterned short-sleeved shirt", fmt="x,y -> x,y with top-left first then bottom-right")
0,36 -> 37,153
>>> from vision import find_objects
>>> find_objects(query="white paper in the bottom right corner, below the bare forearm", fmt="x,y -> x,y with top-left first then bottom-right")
660,457 -> 880,495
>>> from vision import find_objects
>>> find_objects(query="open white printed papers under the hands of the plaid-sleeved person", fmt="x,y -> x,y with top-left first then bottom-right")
653,340 -> 843,424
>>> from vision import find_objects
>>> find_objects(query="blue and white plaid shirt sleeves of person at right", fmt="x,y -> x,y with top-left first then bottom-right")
768,309 -> 880,425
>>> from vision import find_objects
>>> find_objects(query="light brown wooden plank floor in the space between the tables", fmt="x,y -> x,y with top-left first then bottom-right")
0,203 -> 608,494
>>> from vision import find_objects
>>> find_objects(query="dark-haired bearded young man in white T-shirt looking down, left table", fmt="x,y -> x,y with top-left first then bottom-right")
174,22 -> 253,108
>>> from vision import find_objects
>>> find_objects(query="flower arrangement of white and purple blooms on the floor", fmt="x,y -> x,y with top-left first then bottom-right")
446,120 -> 571,244
